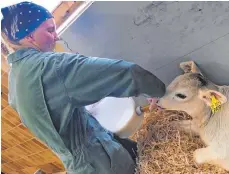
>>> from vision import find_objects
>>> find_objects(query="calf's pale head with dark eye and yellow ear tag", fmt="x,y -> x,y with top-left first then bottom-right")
158,61 -> 227,117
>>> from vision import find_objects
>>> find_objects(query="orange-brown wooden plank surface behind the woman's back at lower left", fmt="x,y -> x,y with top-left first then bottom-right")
1,71 -> 64,174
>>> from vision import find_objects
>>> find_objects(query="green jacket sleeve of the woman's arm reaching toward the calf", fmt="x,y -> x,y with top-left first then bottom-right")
56,53 -> 165,107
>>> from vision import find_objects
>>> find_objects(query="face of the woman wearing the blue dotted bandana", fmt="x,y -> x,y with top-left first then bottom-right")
31,18 -> 58,52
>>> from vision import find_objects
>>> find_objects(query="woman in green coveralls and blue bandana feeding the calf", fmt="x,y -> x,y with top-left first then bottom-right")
1,2 -> 165,174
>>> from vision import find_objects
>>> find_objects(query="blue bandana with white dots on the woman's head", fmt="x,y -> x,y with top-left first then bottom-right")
1,2 -> 53,42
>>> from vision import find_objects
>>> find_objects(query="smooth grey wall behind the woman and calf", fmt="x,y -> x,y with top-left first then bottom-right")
62,1 -> 229,84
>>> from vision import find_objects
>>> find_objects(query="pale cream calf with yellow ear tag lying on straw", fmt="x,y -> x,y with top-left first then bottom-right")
158,61 -> 229,171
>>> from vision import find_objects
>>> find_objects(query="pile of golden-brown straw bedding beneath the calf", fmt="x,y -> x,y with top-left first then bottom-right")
131,111 -> 227,174
